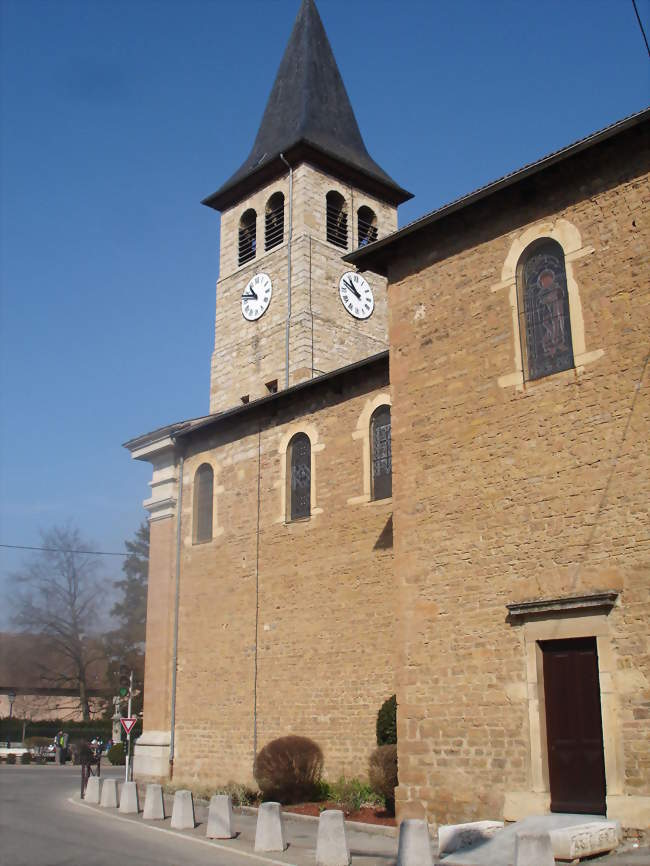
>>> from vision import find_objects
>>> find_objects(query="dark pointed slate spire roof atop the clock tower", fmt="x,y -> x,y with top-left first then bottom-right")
203,0 -> 412,210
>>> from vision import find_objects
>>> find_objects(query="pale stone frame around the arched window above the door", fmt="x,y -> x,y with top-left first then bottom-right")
490,218 -> 605,391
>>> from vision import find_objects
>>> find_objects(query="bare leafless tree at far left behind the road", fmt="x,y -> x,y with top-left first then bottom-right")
13,527 -> 105,721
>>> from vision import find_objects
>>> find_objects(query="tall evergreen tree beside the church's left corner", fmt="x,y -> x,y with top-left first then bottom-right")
107,523 -> 149,713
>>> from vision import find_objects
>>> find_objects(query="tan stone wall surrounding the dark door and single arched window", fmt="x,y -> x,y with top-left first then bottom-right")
389,135 -> 650,822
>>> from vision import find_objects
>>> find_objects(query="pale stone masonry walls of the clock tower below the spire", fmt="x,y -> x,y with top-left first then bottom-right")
210,164 -> 390,412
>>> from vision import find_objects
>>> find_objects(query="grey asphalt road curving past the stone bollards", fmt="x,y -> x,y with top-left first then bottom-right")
0,765 -> 280,866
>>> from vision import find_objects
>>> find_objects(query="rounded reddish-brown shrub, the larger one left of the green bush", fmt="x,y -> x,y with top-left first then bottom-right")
253,735 -> 323,804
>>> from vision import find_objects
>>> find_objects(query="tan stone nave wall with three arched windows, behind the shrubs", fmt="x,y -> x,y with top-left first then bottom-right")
168,371 -> 395,784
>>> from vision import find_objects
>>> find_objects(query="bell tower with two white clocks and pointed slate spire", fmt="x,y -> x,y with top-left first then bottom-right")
203,0 -> 411,413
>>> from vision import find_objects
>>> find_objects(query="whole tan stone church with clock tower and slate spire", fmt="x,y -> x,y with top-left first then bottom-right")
126,0 -> 650,828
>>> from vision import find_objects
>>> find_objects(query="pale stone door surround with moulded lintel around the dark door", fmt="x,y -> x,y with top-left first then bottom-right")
504,591 -> 625,821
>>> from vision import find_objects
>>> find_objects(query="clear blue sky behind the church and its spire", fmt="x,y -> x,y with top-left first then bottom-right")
0,0 -> 650,625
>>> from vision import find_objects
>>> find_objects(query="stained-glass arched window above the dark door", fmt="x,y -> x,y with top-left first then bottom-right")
517,238 -> 574,379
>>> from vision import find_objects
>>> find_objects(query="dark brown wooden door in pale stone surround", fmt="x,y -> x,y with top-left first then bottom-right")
541,638 -> 605,815
